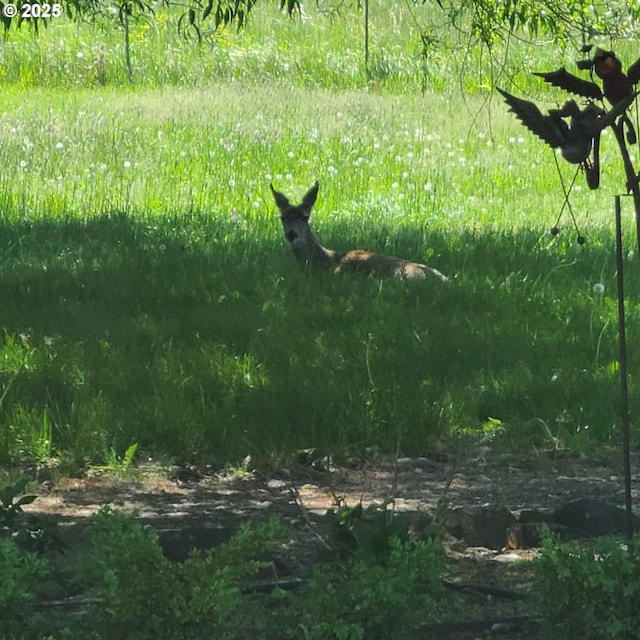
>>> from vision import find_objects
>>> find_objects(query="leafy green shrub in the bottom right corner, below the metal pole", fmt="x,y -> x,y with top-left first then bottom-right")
535,537 -> 640,640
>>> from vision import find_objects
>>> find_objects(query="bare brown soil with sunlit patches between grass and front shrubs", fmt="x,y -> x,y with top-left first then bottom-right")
18,452 -> 640,640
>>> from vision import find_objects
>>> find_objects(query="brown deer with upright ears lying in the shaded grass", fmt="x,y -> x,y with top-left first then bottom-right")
270,181 -> 449,282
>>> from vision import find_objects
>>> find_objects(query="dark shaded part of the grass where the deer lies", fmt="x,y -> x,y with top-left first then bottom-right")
0,214 -> 638,465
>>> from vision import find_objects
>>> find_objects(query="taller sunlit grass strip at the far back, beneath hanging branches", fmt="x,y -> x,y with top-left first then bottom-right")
0,1 -> 635,93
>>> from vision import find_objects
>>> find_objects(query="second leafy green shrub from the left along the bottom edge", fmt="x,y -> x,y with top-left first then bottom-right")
79,507 -> 280,640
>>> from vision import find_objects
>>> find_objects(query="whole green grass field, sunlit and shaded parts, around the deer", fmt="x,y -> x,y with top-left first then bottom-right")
0,3 -> 640,469
